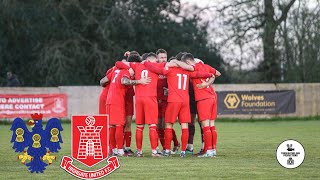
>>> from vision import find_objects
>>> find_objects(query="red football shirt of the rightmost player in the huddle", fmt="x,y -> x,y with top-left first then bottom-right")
192,62 -> 216,101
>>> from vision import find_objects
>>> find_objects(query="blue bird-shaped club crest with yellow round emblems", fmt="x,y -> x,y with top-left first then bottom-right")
10,114 -> 63,173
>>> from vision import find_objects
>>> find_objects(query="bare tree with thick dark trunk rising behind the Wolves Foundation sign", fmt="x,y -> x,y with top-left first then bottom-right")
210,0 -> 296,82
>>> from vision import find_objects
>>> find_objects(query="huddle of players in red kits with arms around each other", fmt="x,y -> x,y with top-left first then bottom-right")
99,49 -> 220,157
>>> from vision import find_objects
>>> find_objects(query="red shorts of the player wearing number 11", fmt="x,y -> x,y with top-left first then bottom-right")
165,102 -> 191,124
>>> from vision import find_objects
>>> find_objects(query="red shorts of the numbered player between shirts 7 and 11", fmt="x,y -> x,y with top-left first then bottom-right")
136,96 -> 158,124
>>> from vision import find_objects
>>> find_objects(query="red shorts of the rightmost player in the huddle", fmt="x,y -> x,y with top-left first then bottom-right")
197,98 -> 217,121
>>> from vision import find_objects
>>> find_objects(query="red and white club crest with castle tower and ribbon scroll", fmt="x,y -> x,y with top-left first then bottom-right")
60,115 -> 120,179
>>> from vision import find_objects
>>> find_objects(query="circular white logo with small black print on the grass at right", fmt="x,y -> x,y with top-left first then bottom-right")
277,139 -> 305,169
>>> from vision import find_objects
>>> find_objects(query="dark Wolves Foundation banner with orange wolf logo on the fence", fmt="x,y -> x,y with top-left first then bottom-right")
217,90 -> 296,114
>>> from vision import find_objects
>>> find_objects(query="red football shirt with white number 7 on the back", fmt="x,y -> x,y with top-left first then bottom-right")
107,68 -> 130,105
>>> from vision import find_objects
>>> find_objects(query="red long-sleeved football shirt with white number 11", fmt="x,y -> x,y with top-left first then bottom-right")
146,63 -> 212,102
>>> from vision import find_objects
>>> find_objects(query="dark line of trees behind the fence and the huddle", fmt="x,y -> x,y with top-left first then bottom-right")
0,0 -> 320,86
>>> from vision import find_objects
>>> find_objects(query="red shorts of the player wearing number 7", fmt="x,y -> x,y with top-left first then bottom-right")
107,104 -> 126,126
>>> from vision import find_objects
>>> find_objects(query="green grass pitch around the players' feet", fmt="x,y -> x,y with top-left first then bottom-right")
0,120 -> 320,179
